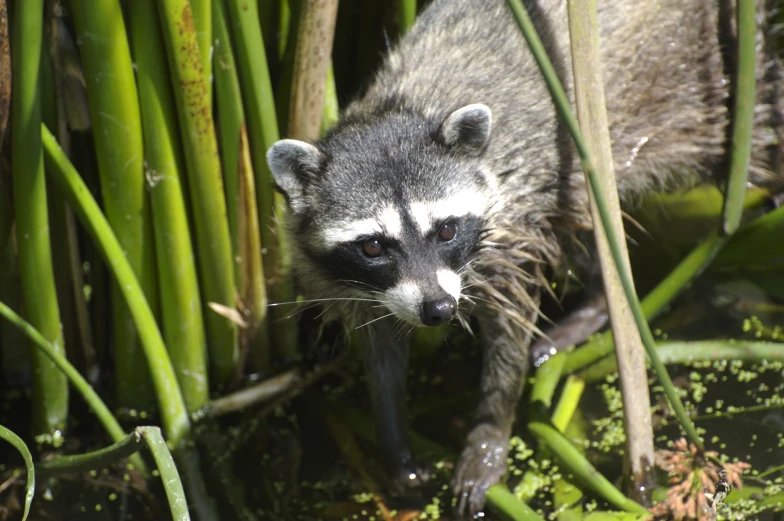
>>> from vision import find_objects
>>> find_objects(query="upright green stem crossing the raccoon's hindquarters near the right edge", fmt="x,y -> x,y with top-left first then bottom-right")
722,0 -> 757,235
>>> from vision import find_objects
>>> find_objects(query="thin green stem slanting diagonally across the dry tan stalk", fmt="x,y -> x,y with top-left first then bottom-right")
507,0 -> 704,450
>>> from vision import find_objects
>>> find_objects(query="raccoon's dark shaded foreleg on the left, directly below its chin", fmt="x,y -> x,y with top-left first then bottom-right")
363,320 -> 425,486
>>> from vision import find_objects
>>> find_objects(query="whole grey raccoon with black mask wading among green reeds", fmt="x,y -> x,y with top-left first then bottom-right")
267,0 -> 782,514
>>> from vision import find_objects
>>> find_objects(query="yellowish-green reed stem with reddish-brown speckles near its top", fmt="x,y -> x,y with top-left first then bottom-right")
156,0 -> 237,387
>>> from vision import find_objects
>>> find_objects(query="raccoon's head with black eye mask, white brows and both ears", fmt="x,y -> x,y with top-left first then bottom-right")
267,105 -> 491,326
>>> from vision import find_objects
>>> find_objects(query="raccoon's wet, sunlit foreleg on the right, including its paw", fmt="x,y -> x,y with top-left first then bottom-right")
452,313 -> 531,516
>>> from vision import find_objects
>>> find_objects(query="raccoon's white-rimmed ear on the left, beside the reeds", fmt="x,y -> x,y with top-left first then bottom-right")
267,139 -> 322,212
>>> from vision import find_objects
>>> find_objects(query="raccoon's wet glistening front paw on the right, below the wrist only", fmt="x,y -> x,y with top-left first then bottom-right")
452,425 -> 509,518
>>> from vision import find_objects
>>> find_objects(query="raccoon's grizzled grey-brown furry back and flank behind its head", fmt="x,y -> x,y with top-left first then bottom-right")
349,0 -> 779,223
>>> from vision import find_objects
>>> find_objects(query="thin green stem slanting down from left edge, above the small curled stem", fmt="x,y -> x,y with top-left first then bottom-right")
0,296 -> 147,474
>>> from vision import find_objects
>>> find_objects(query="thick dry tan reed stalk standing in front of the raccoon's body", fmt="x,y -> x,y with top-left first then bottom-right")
567,0 -> 653,499
